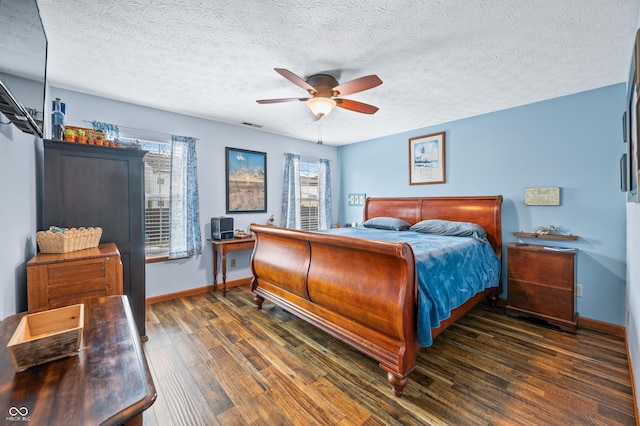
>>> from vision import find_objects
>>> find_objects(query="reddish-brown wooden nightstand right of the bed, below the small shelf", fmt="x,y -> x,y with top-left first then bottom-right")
506,244 -> 578,332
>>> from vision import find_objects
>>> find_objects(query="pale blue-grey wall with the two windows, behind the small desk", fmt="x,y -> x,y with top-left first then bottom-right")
51,87 -> 338,297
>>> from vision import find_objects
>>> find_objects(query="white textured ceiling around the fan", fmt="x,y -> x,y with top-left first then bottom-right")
38,0 -> 639,145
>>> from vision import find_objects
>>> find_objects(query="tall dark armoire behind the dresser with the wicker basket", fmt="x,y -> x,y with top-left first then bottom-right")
39,140 -> 146,338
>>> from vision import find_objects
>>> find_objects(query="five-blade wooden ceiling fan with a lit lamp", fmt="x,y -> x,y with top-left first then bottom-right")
256,68 -> 382,118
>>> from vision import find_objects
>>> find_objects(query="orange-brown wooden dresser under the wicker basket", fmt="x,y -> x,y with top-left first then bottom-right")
27,243 -> 123,312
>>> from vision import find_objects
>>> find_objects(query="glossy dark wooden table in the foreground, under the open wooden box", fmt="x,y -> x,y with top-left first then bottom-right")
0,296 -> 156,425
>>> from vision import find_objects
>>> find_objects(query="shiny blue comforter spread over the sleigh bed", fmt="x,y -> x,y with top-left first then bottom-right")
322,227 -> 500,347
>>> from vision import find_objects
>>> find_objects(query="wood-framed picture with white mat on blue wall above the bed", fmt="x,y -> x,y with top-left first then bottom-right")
409,132 -> 445,185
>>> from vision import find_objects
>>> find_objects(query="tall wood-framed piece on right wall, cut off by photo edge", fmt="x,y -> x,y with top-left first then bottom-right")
624,30 -> 640,202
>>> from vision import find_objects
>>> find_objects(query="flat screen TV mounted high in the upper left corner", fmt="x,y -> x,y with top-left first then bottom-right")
0,0 -> 47,137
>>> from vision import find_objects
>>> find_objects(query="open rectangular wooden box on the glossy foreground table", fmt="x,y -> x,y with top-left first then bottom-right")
7,304 -> 84,371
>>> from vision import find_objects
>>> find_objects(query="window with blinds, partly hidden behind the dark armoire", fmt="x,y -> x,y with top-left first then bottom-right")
120,137 -> 171,255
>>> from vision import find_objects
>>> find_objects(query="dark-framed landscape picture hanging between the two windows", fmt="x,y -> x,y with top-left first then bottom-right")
225,147 -> 267,213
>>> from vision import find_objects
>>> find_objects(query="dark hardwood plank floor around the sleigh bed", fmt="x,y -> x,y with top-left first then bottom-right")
143,286 -> 635,426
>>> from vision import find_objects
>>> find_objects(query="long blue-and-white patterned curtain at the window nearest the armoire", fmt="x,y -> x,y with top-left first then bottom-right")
169,135 -> 202,259
